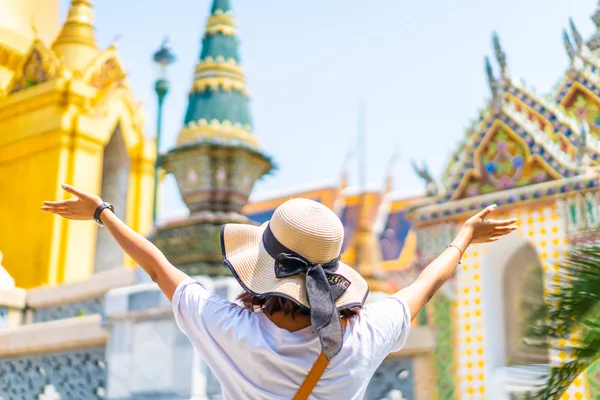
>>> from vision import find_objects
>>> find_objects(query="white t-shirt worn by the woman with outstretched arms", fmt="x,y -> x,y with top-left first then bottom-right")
173,279 -> 411,400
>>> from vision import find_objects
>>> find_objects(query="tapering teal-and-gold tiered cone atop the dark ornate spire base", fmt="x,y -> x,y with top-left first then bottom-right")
177,0 -> 258,148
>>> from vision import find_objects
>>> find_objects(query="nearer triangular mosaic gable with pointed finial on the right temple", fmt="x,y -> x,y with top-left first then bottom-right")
436,34 -> 598,203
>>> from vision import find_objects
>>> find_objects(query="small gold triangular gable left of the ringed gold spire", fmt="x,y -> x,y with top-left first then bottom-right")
8,39 -> 60,94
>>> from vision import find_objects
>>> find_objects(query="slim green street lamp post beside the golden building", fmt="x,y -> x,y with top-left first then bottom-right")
152,39 -> 176,223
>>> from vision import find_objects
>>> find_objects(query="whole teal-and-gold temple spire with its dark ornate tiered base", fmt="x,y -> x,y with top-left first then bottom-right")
157,0 -> 274,276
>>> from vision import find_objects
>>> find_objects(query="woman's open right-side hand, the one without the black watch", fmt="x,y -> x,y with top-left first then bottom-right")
463,205 -> 517,243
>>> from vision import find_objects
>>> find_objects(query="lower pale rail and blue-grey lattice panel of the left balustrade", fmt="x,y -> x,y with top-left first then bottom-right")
0,315 -> 107,400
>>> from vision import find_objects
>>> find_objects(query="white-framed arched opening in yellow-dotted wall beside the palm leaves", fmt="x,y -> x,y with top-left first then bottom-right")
482,235 -> 548,400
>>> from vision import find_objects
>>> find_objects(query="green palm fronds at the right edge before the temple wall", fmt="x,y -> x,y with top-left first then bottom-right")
526,231 -> 600,400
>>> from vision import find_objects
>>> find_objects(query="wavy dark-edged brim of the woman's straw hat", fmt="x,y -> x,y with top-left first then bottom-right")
221,223 -> 369,310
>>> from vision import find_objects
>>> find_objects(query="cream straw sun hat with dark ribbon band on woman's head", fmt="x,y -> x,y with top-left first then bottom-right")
221,198 -> 369,310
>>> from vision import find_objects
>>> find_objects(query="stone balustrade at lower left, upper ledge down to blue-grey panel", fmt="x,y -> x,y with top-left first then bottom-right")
0,269 -> 137,400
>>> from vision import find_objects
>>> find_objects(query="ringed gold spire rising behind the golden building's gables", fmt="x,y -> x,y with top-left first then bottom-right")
52,0 -> 99,71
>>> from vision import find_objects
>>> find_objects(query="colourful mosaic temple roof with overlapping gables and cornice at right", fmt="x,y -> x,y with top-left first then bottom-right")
409,21 -> 600,224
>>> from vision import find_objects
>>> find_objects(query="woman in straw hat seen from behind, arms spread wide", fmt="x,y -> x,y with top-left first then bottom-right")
42,185 -> 516,400
